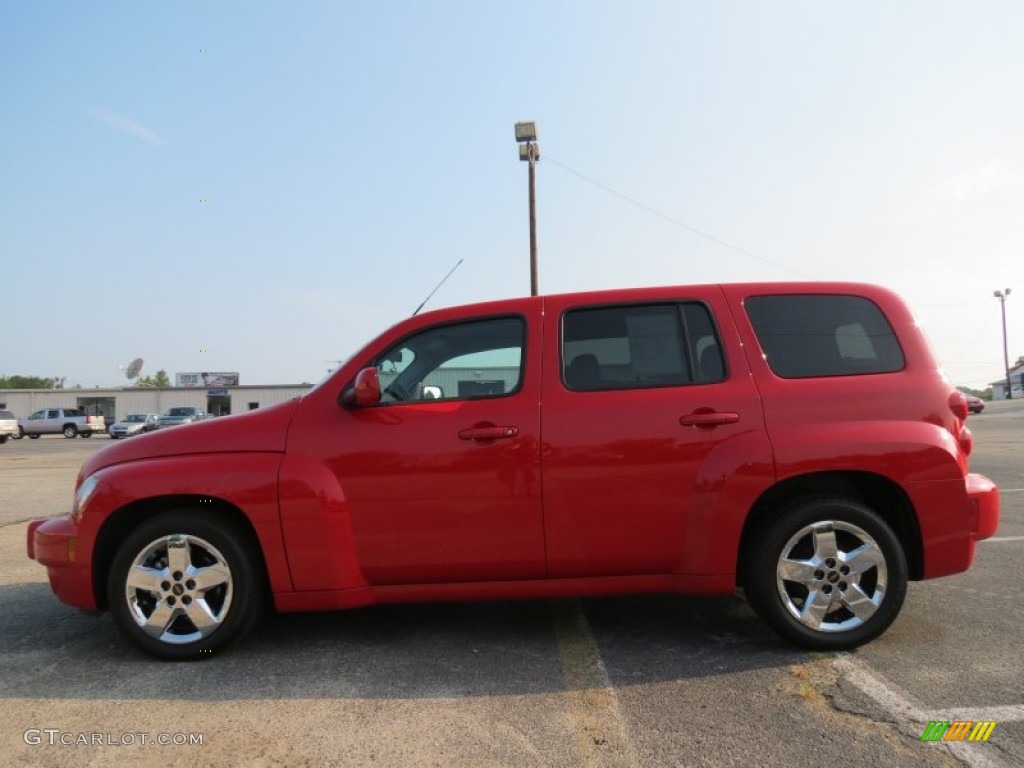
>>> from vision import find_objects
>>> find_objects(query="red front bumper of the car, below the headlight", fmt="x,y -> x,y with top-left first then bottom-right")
27,515 -> 97,610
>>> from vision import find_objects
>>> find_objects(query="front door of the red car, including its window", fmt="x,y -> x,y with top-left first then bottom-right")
315,301 -> 544,585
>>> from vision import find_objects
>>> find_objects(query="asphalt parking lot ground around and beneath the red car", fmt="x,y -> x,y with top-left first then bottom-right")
0,415 -> 1024,768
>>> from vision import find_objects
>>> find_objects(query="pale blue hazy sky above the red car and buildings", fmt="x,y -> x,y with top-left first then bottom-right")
0,0 -> 1024,387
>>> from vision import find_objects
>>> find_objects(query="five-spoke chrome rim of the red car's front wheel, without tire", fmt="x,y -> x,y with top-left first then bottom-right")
125,534 -> 233,644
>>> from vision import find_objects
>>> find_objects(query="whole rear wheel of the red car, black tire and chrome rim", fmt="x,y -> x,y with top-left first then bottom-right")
741,499 -> 907,650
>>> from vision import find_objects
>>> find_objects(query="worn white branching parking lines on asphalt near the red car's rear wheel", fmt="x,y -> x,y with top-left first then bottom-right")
835,653 -> 1024,768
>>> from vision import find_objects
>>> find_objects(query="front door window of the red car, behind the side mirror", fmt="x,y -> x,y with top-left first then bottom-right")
374,317 -> 526,403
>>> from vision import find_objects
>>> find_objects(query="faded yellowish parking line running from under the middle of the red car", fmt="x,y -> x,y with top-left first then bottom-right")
551,600 -> 640,768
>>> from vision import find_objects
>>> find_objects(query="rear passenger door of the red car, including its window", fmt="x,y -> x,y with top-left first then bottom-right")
542,287 -> 771,578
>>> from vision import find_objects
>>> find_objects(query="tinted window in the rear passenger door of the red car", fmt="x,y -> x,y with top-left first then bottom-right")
562,303 -> 725,391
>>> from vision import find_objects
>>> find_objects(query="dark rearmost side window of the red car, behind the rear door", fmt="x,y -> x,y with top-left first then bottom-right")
744,295 -> 904,379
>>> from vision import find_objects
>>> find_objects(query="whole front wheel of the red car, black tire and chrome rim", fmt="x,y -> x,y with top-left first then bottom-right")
106,511 -> 265,660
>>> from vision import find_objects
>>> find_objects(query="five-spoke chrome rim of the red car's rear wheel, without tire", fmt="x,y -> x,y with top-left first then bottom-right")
775,520 -> 889,632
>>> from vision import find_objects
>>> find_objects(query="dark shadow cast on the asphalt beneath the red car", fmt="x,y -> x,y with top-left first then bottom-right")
0,584 -> 856,700
